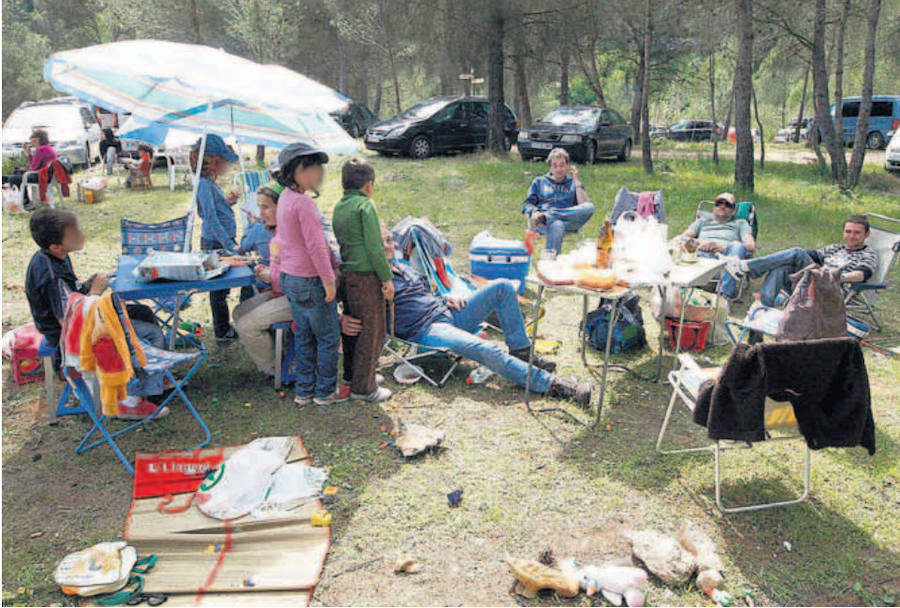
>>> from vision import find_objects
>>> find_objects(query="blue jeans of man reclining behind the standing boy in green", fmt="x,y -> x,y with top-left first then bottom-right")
412,281 -> 553,394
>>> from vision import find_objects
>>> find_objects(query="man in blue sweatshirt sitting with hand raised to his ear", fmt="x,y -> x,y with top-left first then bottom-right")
522,148 -> 594,259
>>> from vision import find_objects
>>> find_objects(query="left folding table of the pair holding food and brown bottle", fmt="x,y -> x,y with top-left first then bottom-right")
525,275 -> 633,427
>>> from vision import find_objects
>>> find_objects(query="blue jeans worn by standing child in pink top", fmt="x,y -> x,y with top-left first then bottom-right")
281,272 -> 341,399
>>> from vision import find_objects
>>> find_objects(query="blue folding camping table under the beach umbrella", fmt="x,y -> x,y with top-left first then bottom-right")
113,255 -> 255,350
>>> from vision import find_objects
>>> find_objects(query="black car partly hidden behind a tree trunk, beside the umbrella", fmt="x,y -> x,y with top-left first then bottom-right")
365,95 -> 519,159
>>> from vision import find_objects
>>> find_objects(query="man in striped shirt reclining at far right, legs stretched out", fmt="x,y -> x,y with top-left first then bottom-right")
726,215 -> 878,306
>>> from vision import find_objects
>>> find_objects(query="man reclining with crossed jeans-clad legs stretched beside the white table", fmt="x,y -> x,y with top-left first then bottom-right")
341,228 -> 591,405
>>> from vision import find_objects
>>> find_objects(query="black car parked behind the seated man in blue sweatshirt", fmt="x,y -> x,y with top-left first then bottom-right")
518,106 -> 634,164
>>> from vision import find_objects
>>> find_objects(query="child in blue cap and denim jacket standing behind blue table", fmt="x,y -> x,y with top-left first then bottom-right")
191,135 -> 240,341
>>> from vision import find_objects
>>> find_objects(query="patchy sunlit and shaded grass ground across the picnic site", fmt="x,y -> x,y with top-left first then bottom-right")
2,148 -> 900,605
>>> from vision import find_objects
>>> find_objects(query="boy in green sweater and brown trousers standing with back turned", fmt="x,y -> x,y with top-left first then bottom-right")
332,158 -> 394,403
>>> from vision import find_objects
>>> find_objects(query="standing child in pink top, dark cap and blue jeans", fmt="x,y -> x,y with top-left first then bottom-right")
277,143 -> 347,406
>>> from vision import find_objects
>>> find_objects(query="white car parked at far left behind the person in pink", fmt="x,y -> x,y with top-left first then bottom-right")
3,97 -> 102,167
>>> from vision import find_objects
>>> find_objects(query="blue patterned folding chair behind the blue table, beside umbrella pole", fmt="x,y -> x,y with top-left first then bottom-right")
120,215 -> 196,347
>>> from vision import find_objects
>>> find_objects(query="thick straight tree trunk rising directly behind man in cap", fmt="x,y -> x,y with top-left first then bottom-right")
734,0 -> 754,192
